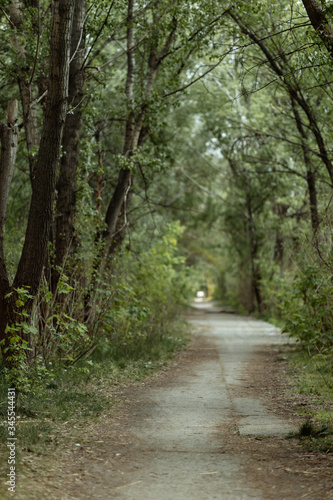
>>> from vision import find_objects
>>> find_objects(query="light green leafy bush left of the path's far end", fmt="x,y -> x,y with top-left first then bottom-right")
93,223 -> 193,356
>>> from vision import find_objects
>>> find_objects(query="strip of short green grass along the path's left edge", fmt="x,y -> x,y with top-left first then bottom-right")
0,321 -> 189,484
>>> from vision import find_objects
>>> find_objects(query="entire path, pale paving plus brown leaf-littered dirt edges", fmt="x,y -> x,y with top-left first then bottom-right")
3,309 -> 333,500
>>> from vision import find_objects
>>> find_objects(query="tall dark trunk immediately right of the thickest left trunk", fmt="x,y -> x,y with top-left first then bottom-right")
52,0 -> 86,291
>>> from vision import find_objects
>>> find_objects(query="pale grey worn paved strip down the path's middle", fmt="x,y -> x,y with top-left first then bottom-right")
86,310 -> 298,500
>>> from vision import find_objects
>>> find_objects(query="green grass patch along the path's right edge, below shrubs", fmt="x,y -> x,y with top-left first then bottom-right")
282,350 -> 333,452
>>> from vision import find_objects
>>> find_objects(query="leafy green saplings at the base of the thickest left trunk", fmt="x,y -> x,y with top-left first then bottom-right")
2,275 -> 91,397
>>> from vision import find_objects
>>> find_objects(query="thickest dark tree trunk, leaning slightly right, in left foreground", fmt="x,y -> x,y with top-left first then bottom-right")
0,0 -> 74,363
